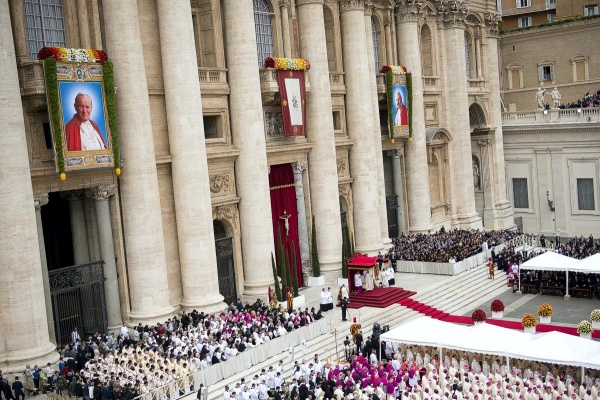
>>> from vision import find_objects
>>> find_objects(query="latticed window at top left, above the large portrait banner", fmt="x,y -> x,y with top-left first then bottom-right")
24,0 -> 65,60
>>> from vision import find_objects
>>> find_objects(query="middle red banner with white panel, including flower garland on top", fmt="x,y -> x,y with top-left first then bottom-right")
265,57 -> 310,136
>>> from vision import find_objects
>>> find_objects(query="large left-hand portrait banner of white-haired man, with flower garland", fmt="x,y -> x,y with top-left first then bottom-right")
38,47 -> 121,180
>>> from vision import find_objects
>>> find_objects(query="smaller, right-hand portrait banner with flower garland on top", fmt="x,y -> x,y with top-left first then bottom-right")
381,65 -> 412,143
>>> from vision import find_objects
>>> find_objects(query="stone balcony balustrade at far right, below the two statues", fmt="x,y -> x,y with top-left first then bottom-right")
502,107 -> 600,126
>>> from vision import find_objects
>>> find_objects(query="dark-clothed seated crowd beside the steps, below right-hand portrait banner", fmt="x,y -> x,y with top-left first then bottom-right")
386,229 -> 521,264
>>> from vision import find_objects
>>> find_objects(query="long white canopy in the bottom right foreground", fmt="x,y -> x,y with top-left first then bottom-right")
381,317 -> 600,369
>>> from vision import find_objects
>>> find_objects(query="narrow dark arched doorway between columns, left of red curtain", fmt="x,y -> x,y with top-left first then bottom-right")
213,221 -> 237,304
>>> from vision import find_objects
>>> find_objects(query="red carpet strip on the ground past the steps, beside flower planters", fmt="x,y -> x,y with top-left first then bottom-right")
397,297 -> 600,339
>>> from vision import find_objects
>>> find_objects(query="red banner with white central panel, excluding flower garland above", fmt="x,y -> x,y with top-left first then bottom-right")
277,70 -> 306,136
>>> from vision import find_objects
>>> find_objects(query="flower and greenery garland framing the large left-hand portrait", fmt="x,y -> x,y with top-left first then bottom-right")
38,47 -> 121,181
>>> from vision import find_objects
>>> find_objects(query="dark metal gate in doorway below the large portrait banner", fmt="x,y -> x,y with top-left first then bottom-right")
48,261 -> 107,345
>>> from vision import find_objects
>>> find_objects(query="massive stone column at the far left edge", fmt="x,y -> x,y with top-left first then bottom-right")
0,0 -> 58,372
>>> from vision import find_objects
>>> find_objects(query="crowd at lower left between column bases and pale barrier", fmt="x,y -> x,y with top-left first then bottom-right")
8,299 -> 321,400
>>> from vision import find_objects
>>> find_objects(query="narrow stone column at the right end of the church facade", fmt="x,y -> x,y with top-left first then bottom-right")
484,13 -> 515,229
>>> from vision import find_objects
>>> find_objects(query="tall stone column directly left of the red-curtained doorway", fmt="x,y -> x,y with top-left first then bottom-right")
223,0 -> 275,298
